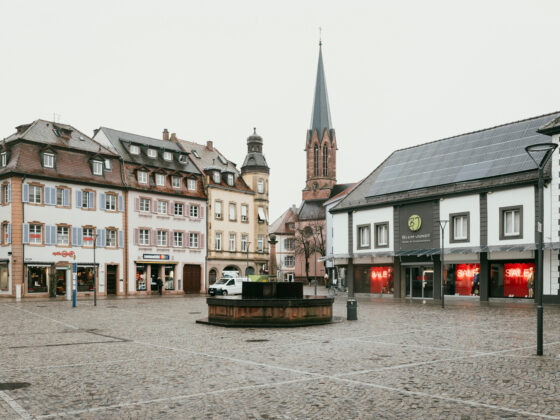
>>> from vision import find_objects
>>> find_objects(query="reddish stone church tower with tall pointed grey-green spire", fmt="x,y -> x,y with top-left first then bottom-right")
302,42 -> 337,201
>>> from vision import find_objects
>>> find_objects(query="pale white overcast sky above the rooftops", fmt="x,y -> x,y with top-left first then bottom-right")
0,0 -> 560,220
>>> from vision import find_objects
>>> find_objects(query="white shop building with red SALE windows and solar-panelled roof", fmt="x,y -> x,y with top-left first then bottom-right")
329,113 -> 560,303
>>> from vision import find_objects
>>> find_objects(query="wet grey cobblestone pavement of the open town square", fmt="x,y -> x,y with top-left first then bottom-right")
0,288 -> 560,419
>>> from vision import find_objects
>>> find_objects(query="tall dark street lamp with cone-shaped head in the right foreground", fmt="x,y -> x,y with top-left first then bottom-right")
525,143 -> 558,356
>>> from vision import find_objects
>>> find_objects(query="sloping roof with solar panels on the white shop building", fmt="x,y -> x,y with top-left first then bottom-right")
333,112 -> 560,211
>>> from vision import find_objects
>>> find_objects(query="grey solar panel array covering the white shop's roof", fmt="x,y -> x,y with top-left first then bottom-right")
367,113 -> 560,197
